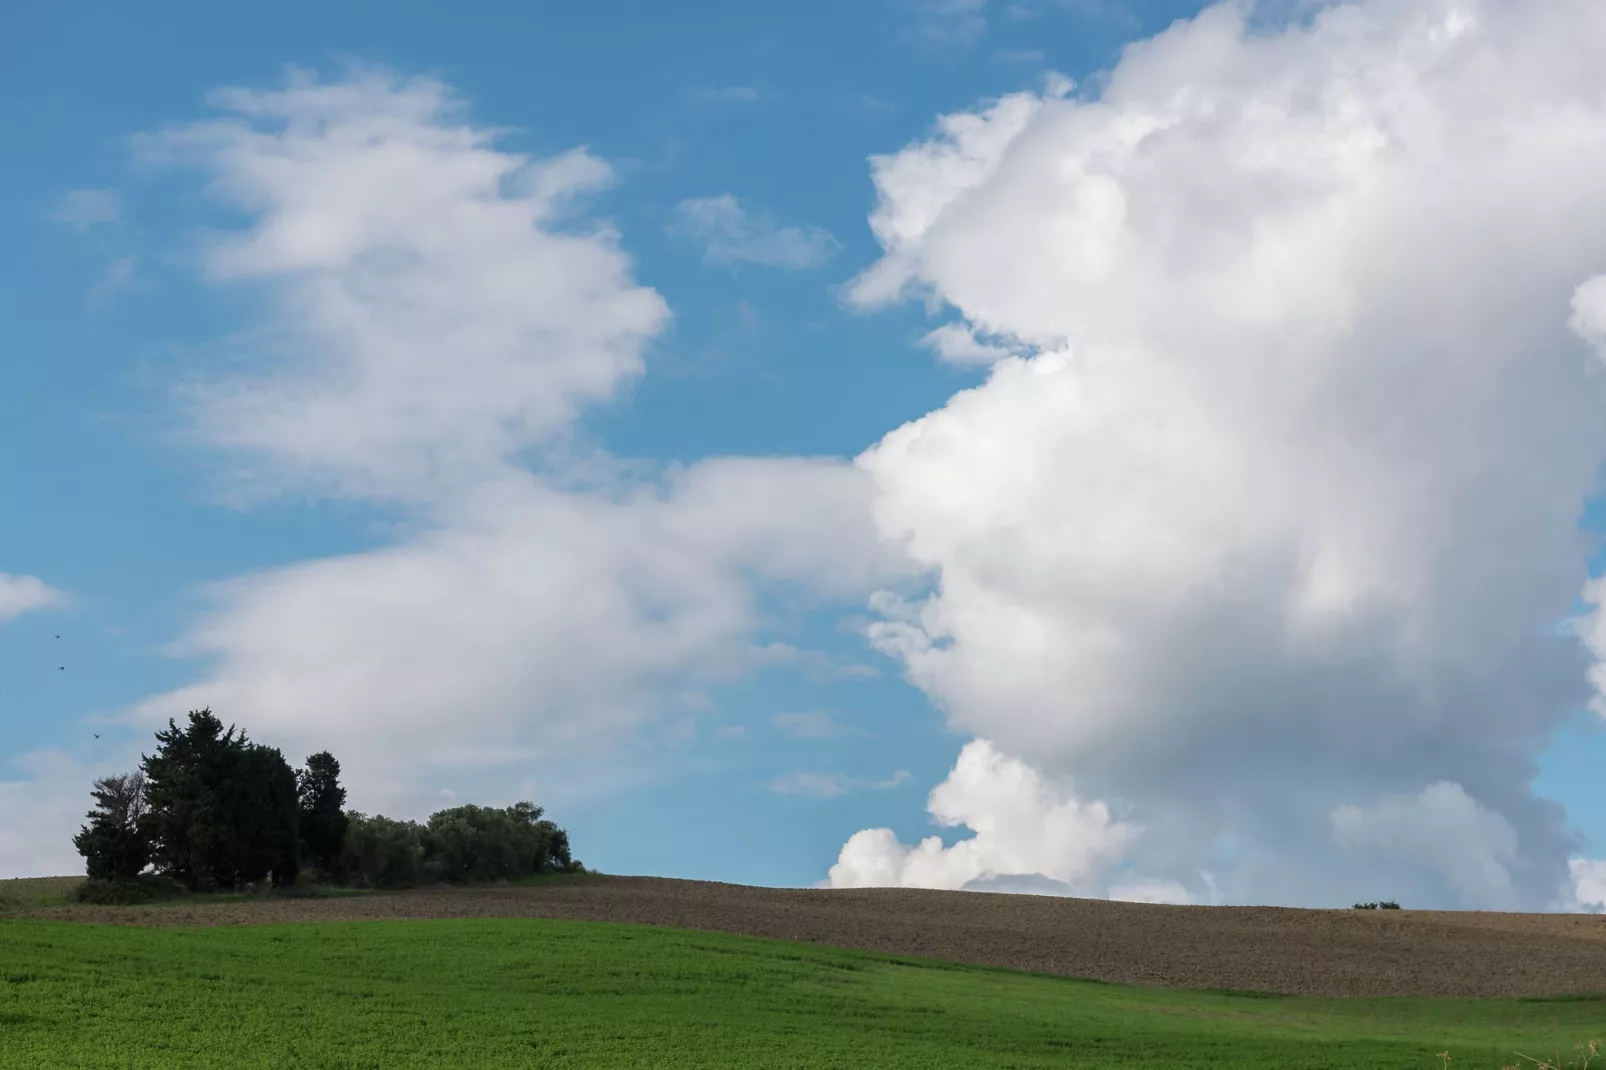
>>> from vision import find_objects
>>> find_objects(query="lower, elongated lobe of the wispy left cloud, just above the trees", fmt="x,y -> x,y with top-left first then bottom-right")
130,459 -> 882,771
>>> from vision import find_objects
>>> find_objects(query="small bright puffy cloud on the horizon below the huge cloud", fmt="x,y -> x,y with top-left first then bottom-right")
830,739 -> 1139,893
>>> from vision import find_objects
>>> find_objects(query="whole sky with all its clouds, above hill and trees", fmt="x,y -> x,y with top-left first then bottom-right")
0,0 -> 1606,911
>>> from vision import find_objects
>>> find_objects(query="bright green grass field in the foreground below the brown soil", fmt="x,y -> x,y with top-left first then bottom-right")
0,919 -> 1606,1070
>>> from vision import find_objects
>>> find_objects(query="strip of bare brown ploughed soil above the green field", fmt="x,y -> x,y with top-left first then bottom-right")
12,877 -> 1606,996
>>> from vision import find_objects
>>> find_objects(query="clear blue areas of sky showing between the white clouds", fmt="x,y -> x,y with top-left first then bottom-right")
9,0 -> 1606,900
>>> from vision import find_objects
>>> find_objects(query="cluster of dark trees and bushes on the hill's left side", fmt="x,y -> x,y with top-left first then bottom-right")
72,709 -> 585,892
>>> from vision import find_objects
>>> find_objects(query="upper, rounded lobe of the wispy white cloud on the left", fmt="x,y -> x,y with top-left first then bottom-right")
143,72 -> 668,500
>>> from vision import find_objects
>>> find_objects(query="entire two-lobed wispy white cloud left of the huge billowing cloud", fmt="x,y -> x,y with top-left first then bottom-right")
65,71 -> 907,815
